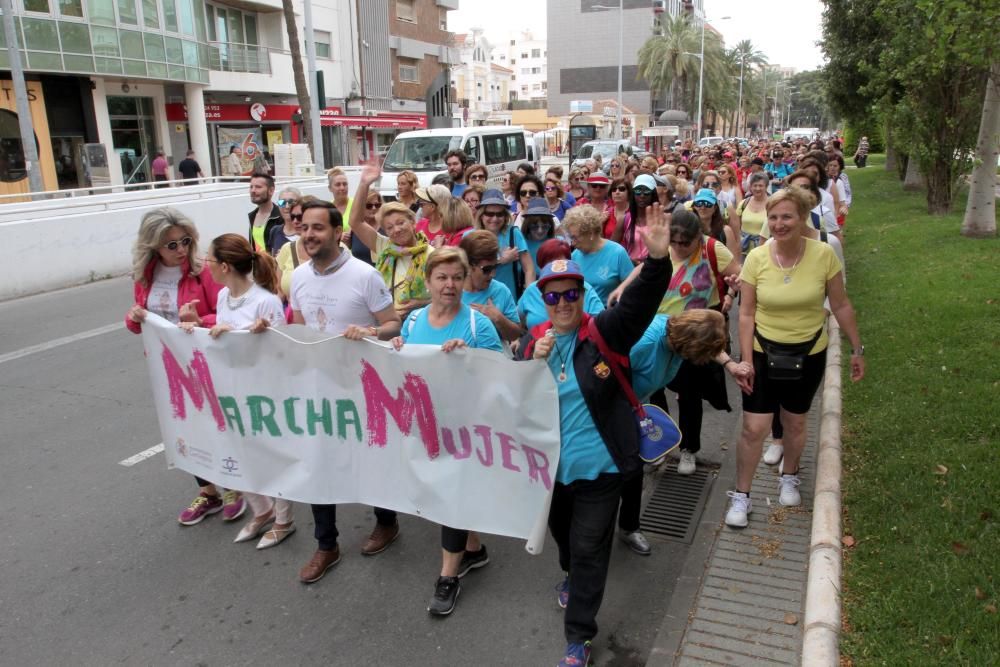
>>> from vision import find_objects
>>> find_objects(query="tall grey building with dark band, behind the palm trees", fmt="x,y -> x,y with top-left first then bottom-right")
548,0 -> 703,115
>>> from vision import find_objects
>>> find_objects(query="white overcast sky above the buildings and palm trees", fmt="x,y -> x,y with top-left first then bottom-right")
448,0 -> 823,71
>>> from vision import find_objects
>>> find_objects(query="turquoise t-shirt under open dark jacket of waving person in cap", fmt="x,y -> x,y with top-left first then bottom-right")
548,331 -> 618,484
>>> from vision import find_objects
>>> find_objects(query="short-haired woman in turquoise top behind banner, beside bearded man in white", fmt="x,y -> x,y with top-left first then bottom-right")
344,247 -> 503,616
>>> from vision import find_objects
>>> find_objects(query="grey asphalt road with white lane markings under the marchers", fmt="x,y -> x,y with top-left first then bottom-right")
0,278 -> 732,666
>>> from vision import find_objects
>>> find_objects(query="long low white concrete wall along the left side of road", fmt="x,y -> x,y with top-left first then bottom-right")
0,177 -> 344,300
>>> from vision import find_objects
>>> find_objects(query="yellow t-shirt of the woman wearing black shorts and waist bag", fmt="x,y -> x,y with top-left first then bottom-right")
740,239 -> 843,354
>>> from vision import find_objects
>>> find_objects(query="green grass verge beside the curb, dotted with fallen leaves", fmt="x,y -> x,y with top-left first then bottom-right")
841,156 -> 1000,665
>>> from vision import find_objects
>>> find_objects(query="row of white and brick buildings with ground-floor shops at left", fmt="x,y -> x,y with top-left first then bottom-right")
0,0 -> 458,194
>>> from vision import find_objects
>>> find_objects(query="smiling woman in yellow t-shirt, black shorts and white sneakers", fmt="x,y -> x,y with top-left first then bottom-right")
726,186 -> 865,528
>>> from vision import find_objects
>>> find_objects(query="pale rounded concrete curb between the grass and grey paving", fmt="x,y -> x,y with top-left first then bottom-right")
802,318 -> 842,667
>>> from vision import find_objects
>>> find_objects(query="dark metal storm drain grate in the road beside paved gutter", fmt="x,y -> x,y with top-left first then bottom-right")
640,462 -> 715,544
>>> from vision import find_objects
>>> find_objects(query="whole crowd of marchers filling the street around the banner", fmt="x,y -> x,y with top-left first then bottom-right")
125,140 -> 864,665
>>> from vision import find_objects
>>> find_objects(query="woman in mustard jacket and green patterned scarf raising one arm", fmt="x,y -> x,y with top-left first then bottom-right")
351,158 -> 434,319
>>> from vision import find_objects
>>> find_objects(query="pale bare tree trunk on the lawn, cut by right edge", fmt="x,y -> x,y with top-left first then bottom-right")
962,62 -> 1000,238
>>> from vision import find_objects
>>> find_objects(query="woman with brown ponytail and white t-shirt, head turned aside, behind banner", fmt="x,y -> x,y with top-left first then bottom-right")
189,234 -> 295,549
